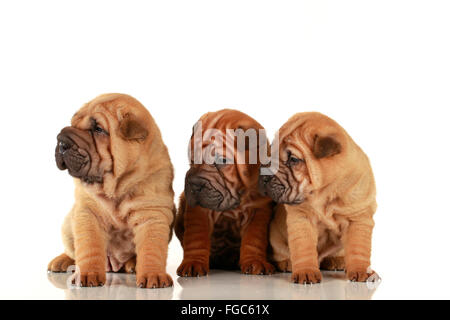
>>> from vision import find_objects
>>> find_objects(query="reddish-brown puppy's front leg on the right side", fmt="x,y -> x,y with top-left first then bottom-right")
239,209 -> 275,274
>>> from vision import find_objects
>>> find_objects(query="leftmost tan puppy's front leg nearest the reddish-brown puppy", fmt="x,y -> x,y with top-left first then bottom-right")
128,208 -> 173,288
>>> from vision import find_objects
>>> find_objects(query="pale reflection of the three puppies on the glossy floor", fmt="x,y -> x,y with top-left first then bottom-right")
48,270 -> 381,300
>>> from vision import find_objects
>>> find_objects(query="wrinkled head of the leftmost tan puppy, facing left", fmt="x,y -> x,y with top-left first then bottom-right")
55,94 -> 148,184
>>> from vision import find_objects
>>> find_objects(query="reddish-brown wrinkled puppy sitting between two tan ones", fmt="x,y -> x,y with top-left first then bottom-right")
175,109 -> 275,277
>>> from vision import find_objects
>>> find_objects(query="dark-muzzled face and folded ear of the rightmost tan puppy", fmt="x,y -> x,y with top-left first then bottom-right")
258,136 -> 340,204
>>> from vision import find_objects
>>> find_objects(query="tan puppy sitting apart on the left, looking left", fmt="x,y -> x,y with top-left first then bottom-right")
48,94 -> 175,288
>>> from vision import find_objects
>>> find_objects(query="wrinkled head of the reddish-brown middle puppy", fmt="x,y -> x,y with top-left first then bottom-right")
184,110 -> 267,211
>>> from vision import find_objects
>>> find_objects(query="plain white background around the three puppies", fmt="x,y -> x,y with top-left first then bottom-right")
0,0 -> 450,299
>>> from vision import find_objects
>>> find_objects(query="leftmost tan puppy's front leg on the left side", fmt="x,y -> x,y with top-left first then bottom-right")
72,210 -> 106,287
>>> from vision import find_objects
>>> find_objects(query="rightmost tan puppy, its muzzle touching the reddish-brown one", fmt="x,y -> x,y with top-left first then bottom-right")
260,112 -> 377,283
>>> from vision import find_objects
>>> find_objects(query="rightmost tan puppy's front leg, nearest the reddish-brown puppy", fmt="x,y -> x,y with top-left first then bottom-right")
286,206 -> 322,284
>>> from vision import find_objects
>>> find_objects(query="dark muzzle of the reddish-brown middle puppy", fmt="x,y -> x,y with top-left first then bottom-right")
184,177 -> 240,211
